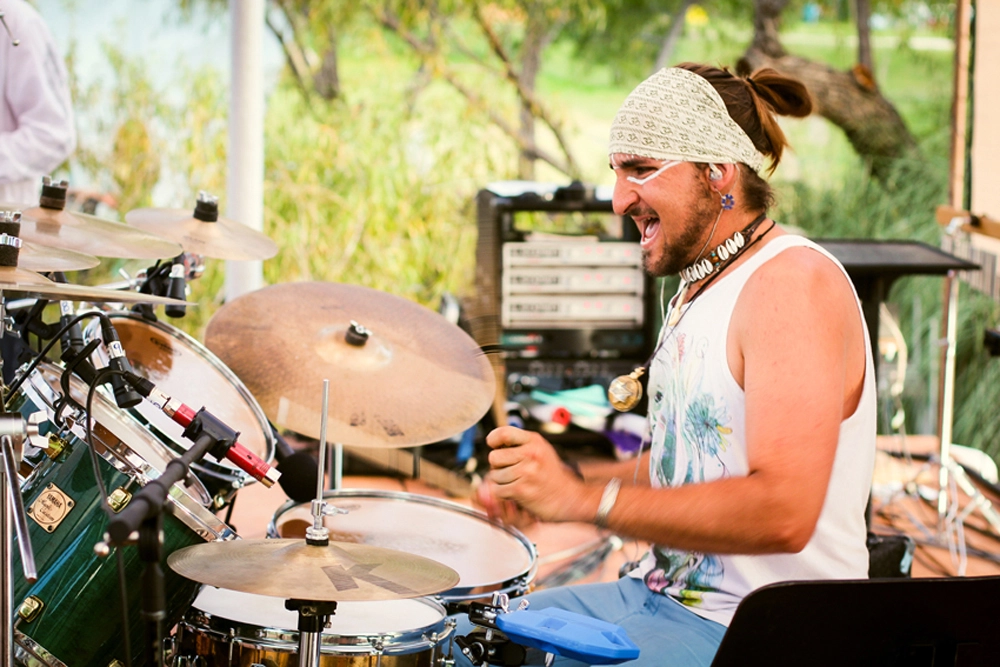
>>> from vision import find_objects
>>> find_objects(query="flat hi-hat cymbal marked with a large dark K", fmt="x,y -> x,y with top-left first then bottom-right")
167,539 -> 459,602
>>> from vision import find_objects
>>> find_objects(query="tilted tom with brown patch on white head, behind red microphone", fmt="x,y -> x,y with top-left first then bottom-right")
86,311 -> 275,509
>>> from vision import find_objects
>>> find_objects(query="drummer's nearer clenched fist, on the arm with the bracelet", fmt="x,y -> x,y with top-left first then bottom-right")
485,426 -> 596,521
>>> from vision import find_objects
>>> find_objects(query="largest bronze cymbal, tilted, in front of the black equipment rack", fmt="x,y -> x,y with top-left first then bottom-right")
205,282 -> 496,447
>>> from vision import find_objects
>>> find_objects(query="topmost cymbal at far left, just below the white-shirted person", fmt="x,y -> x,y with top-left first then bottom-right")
7,204 -> 181,259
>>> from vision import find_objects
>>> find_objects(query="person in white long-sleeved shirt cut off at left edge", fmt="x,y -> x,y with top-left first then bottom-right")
0,0 -> 76,205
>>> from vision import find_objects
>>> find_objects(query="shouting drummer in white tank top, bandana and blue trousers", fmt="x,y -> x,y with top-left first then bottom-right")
457,64 -> 876,666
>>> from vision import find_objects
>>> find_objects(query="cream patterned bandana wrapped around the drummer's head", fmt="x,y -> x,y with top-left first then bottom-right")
608,67 -> 764,173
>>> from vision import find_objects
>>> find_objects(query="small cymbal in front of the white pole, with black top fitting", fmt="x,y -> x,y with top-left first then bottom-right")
125,208 -> 278,260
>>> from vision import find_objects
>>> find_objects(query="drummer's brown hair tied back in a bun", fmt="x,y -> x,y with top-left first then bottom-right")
677,63 -> 813,211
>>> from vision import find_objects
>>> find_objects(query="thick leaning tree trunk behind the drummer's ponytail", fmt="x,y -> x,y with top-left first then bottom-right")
737,0 -> 917,181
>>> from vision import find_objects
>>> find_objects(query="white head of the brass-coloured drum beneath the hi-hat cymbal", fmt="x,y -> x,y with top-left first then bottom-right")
193,586 -> 444,643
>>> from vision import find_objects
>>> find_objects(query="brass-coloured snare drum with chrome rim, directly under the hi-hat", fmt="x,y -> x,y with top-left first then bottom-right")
173,586 -> 453,667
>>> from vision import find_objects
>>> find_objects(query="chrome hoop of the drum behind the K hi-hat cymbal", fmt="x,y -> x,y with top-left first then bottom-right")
267,489 -> 538,602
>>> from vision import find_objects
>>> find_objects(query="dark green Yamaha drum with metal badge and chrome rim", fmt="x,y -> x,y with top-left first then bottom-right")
13,363 -> 235,667
